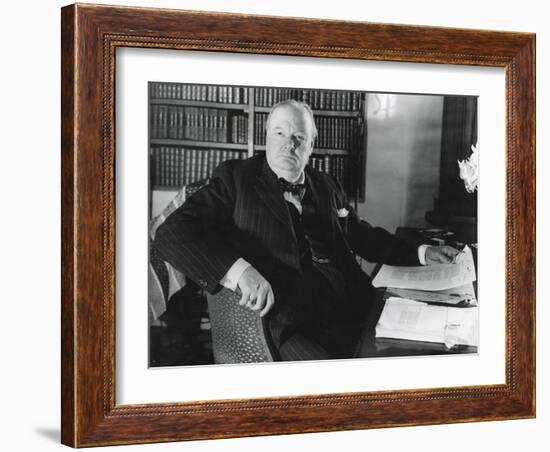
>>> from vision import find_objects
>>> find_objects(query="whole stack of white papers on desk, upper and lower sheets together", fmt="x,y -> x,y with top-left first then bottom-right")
373,247 -> 479,348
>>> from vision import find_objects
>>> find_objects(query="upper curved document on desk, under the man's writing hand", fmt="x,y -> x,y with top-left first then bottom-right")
372,247 -> 476,291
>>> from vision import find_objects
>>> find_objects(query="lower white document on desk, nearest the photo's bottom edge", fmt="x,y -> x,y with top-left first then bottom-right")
376,297 -> 478,348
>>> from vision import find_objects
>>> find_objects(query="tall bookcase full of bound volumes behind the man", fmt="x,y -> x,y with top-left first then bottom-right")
149,82 -> 366,203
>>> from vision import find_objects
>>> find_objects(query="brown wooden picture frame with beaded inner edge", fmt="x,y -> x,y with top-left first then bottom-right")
61,4 -> 535,447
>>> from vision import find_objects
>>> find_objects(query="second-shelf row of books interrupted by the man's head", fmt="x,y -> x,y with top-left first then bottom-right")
254,113 -> 359,149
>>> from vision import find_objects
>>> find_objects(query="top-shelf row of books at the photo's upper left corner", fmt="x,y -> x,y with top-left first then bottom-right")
149,82 -> 248,104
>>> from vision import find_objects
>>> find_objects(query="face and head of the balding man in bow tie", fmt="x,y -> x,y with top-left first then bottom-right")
266,105 -> 313,178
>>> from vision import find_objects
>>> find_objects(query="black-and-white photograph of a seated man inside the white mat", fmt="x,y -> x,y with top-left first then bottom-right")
149,81 -> 482,367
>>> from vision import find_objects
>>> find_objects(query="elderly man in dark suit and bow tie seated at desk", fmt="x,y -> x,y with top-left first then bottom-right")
155,100 -> 458,360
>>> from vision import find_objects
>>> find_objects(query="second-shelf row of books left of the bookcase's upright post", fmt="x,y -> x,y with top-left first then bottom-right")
151,105 -> 248,144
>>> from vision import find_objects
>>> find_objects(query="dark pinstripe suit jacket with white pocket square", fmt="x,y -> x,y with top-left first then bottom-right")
155,156 -> 419,360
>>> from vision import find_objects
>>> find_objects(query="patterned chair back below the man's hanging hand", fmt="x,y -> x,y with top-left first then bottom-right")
207,288 -> 273,364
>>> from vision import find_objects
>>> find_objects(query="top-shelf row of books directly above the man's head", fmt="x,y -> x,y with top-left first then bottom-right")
254,88 -> 361,111
